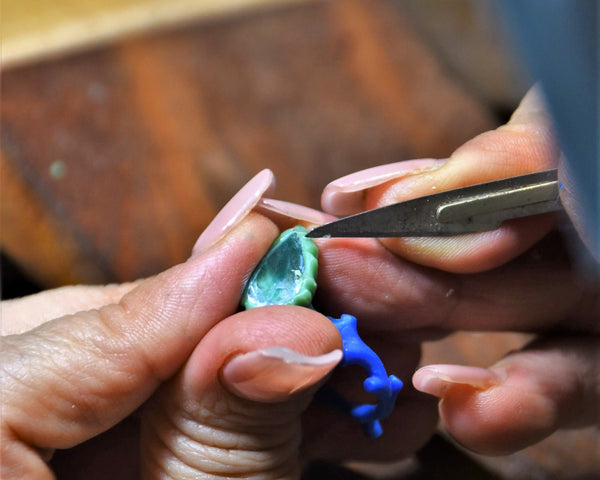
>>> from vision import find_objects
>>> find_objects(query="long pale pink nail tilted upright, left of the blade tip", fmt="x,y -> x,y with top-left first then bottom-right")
192,169 -> 275,256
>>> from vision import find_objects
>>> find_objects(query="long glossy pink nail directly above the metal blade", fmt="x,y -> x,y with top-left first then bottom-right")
321,158 -> 447,215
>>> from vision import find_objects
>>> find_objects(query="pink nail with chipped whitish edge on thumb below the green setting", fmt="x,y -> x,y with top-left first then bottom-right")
222,347 -> 342,402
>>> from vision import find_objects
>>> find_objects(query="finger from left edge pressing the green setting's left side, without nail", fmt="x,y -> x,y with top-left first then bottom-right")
0,214 -> 277,478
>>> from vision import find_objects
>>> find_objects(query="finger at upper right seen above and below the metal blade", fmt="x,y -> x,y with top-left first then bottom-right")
323,87 -> 559,273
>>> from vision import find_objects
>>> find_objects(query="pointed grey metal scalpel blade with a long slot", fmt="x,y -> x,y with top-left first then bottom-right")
307,169 -> 562,238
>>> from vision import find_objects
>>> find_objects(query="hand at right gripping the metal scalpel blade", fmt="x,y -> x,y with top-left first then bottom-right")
318,91 -> 600,453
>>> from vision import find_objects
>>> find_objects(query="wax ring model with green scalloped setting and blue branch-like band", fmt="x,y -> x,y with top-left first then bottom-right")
241,226 -> 402,438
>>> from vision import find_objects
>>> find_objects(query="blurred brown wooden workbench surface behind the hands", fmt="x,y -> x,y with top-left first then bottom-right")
0,0 -> 600,480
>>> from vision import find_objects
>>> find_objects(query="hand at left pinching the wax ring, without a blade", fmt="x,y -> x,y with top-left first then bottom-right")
0,172 -> 435,479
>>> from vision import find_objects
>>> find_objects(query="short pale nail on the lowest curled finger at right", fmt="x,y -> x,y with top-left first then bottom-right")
412,365 -> 505,398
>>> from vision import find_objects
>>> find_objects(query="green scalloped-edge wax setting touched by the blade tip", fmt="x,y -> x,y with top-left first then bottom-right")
241,226 -> 318,310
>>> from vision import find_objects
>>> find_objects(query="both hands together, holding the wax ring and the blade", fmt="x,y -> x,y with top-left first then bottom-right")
0,89 -> 600,479
